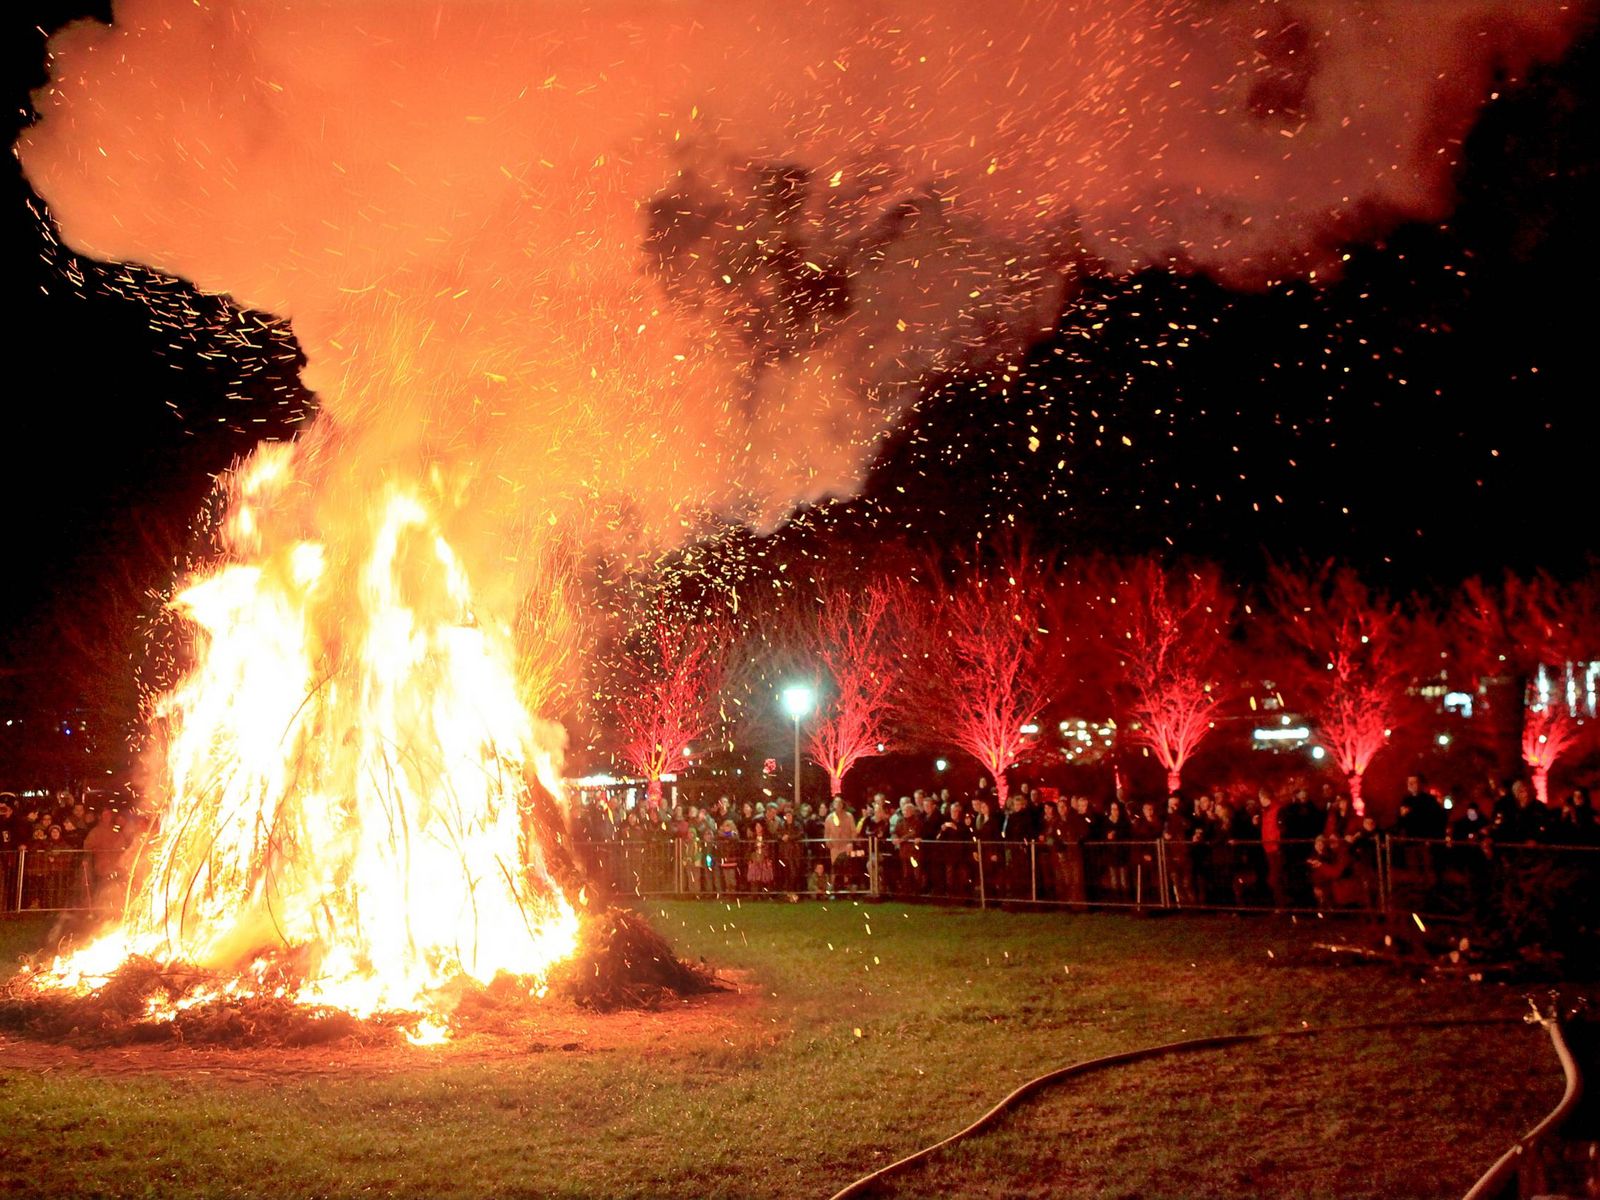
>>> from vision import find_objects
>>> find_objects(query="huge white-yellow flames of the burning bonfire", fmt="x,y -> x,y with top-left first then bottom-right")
38,446 -> 578,1036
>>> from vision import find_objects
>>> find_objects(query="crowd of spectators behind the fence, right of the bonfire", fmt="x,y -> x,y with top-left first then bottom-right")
576,774 -> 1600,909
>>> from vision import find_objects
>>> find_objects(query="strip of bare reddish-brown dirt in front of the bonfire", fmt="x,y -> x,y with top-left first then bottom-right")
0,973 -> 763,1082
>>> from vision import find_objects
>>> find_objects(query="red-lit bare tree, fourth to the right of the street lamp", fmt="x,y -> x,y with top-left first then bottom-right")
1267,563 -> 1437,813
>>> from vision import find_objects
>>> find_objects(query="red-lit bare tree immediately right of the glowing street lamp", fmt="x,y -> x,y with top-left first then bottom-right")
790,581 -> 906,795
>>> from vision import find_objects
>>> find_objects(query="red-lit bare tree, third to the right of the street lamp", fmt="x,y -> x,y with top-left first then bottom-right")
1086,558 -> 1234,792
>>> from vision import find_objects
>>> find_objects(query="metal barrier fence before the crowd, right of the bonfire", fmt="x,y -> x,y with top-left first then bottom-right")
576,834 -> 1600,917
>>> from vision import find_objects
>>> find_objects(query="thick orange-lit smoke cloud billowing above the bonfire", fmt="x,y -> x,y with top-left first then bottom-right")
19,0 -> 1582,598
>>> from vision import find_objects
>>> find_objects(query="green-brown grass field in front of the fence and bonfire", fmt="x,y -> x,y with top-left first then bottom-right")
0,902 -> 1562,1197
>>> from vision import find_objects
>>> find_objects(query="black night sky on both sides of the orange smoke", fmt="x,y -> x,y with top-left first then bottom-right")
0,3 -> 1600,742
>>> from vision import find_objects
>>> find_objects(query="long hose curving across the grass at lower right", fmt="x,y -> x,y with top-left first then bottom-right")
830,1014 -> 1578,1200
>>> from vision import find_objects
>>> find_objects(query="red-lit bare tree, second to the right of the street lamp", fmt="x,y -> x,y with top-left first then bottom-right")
906,549 -> 1061,803
